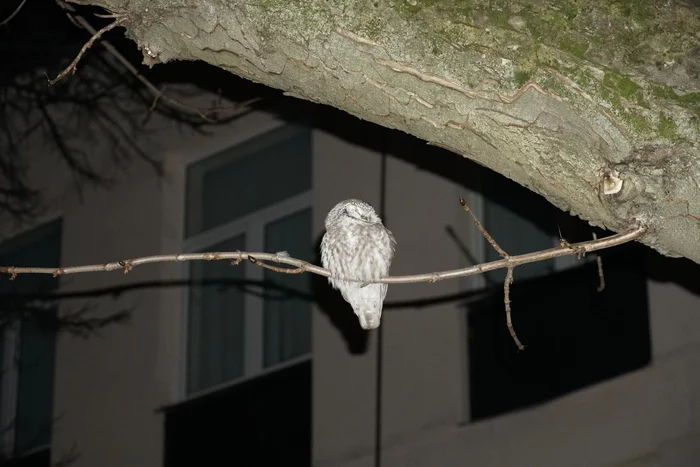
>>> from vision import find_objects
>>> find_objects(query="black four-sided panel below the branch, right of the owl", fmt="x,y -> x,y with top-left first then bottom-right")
468,245 -> 651,421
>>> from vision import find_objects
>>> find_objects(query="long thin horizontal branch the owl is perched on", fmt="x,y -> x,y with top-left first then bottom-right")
0,226 -> 647,284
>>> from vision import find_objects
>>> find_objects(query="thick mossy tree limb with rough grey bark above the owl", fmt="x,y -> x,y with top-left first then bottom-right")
72,0 -> 700,263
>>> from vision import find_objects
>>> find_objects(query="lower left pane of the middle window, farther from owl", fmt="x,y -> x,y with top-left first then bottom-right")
187,235 -> 245,393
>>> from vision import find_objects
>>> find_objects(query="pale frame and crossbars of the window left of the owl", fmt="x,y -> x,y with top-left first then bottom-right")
178,120 -> 314,402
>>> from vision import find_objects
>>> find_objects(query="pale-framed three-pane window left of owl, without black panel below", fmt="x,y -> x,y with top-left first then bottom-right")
185,125 -> 314,395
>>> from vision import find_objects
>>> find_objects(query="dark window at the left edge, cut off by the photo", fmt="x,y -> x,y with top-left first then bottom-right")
0,221 -> 61,465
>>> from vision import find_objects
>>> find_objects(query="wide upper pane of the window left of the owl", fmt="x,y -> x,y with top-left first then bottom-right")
186,126 -> 311,237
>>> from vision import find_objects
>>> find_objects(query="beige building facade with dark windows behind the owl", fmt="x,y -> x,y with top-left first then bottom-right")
0,99 -> 700,467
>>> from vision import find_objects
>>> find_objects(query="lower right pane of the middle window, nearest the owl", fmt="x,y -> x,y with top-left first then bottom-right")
264,209 -> 314,366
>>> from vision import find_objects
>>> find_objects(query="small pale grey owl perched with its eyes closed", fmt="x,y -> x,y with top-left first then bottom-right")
321,199 -> 396,329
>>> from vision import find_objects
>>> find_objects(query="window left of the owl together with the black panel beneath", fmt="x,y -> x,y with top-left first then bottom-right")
164,125 -> 315,467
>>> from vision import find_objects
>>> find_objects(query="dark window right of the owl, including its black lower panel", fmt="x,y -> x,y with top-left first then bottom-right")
467,174 -> 651,421
